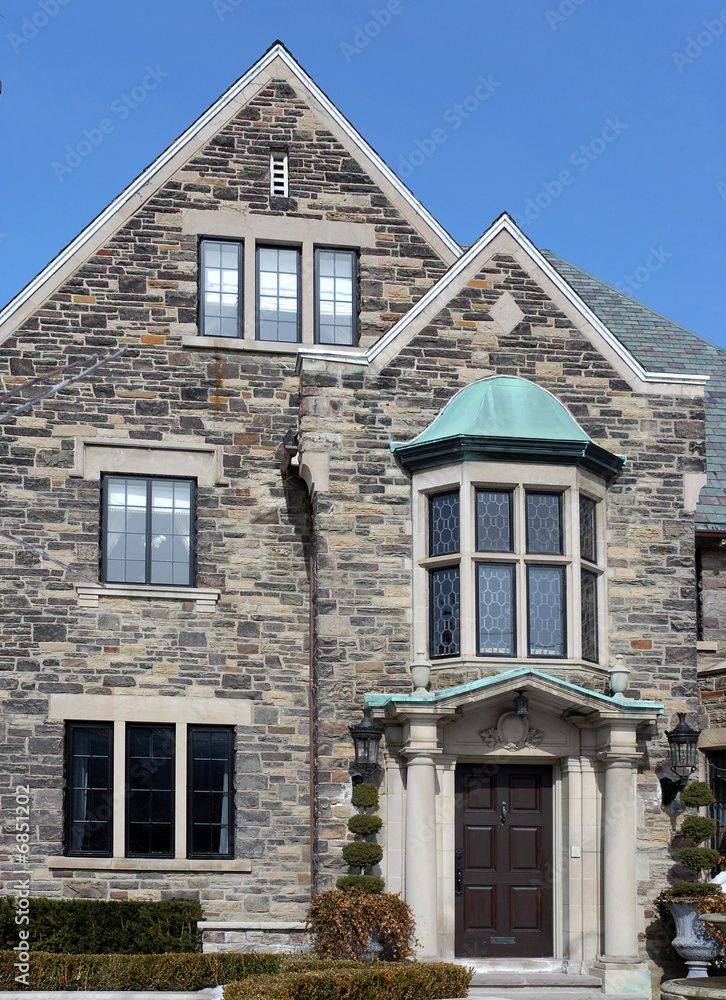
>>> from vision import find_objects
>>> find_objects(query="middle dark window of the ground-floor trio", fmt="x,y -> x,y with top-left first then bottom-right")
126,723 -> 175,858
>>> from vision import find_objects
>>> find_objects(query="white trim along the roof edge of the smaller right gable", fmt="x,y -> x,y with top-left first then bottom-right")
366,212 -> 710,385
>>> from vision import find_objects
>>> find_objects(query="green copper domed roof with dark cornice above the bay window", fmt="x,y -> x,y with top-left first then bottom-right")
391,375 -> 624,478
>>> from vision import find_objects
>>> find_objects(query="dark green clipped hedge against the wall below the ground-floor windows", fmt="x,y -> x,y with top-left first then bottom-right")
0,896 -> 202,955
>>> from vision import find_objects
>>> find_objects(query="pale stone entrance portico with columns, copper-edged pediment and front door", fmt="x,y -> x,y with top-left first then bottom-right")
366,668 -> 662,993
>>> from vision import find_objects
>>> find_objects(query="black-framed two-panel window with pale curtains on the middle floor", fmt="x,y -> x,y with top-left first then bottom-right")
102,476 -> 194,587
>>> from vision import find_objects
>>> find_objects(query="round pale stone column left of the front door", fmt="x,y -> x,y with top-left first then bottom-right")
404,749 -> 438,959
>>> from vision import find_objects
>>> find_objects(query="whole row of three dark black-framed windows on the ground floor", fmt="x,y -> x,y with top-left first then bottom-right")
66,722 -> 234,858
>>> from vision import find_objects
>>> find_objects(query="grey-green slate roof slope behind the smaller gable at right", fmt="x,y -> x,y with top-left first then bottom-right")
542,250 -> 726,531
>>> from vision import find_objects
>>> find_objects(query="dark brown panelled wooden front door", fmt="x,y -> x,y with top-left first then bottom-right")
455,764 -> 553,958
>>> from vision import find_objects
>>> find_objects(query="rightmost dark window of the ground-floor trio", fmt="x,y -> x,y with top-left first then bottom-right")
187,726 -> 234,858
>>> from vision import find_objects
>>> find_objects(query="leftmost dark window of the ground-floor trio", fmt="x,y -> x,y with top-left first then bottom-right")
65,722 -> 113,857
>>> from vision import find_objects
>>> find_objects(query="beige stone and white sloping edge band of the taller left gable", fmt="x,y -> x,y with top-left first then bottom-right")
0,42 -> 461,342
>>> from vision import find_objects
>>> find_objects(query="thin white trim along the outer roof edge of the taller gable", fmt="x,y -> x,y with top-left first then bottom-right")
0,42 -> 462,334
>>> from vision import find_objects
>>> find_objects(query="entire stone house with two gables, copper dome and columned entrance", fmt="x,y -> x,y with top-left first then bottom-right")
0,37 -> 726,993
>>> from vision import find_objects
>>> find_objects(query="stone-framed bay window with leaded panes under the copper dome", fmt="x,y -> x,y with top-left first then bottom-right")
422,484 -> 602,662
